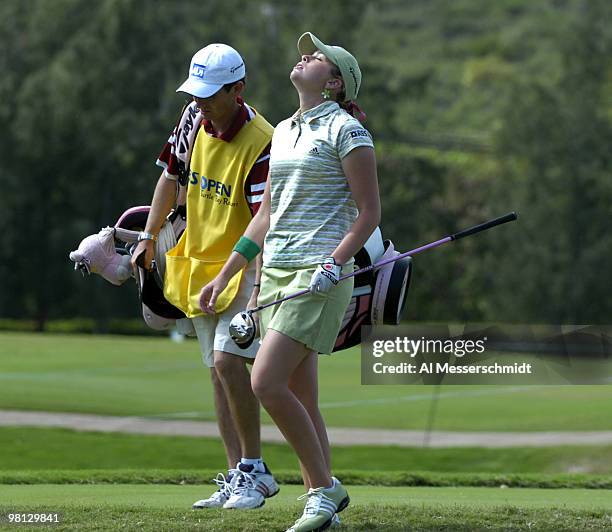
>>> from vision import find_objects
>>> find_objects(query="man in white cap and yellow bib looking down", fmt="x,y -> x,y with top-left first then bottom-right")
132,44 -> 279,509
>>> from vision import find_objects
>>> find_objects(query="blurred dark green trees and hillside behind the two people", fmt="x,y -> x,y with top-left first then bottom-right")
0,0 -> 612,324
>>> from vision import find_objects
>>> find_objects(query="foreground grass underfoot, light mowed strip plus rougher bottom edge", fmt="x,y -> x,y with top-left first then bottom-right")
0,485 -> 612,531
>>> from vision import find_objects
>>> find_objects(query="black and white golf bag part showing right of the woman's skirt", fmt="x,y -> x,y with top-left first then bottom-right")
334,228 -> 412,351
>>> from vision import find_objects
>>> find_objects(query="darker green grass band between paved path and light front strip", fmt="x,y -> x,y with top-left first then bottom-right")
0,427 -> 612,474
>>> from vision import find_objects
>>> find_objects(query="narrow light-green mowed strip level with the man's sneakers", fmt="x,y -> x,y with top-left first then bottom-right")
0,484 -> 612,512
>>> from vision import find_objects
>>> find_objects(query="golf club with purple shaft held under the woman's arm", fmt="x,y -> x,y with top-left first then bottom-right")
229,212 -> 518,349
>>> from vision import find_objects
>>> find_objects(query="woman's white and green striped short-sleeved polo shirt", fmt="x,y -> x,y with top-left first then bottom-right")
263,102 -> 374,268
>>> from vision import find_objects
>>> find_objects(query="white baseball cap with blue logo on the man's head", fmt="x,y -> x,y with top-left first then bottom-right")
176,44 -> 246,98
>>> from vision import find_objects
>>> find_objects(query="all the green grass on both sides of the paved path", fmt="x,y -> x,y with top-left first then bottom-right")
0,333 -> 612,532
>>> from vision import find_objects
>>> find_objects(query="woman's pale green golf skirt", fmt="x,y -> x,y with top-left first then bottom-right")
257,263 -> 353,354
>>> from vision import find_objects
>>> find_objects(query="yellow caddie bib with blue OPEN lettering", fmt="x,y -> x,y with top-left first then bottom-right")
164,114 -> 273,318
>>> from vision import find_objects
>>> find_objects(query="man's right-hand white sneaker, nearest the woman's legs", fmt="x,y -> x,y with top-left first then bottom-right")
223,464 -> 279,510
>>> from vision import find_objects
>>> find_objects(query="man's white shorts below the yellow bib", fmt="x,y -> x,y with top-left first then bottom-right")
191,261 -> 259,368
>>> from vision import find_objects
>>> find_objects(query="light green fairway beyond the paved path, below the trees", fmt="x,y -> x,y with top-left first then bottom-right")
0,333 -> 612,432
